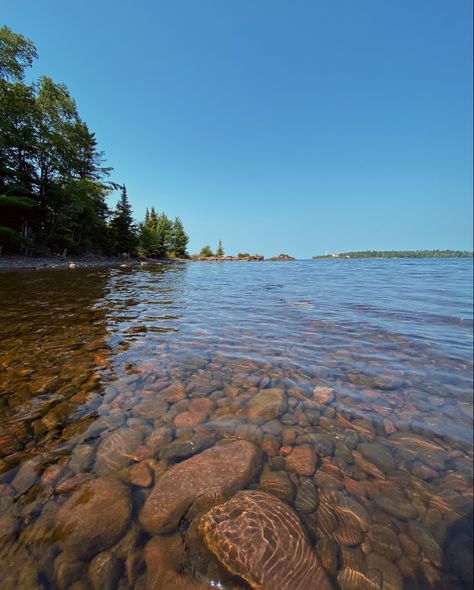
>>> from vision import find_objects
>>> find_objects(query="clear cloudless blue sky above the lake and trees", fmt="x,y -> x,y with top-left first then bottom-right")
0,0 -> 472,258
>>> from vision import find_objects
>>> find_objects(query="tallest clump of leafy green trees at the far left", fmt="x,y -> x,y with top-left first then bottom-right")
0,27 -> 111,254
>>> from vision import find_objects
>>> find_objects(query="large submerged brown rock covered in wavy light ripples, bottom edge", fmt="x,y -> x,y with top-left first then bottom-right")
199,491 -> 331,590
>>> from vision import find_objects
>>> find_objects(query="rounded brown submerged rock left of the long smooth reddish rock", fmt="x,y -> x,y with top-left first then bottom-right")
57,479 -> 132,558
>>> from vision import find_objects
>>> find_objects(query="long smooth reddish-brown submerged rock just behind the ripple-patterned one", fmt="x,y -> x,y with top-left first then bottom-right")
139,440 -> 260,534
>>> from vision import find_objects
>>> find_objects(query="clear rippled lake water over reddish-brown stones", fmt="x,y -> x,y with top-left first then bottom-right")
0,260 -> 473,590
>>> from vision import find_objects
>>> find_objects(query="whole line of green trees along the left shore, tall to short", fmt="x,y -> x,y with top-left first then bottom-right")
0,26 -> 188,257
